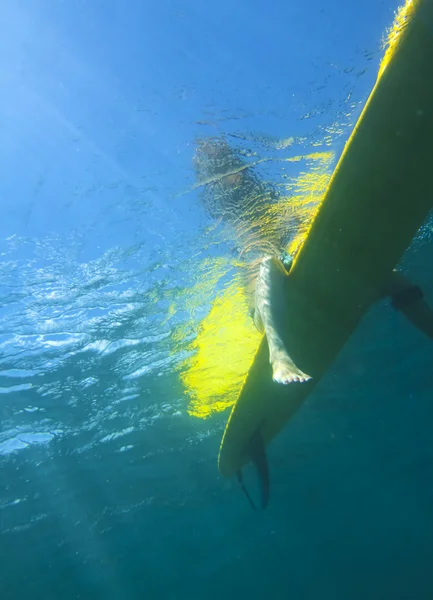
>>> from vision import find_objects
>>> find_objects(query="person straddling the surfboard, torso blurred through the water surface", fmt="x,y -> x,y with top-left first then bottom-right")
193,138 -> 433,384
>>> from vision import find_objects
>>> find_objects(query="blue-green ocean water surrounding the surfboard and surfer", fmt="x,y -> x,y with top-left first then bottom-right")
0,0 -> 433,600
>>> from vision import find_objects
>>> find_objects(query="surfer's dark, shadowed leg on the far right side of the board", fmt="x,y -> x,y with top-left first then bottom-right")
383,271 -> 433,339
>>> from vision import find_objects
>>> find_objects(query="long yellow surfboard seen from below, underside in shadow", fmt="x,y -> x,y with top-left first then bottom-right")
219,0 -> 433,492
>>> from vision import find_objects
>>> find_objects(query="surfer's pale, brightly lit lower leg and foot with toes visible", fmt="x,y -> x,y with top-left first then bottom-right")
254,256 -> 311,383
